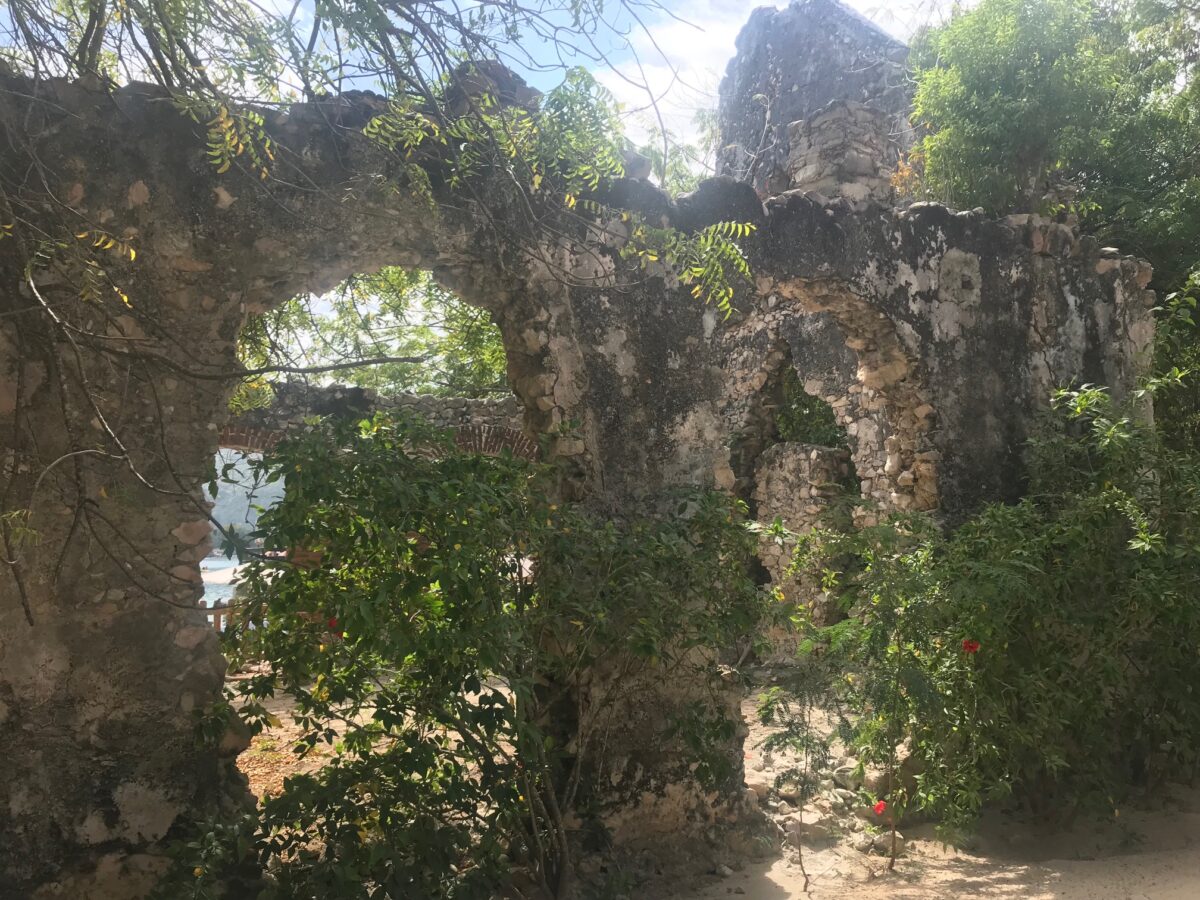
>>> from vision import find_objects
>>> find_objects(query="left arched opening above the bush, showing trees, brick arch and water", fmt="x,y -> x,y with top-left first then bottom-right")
210,266 -> 538,631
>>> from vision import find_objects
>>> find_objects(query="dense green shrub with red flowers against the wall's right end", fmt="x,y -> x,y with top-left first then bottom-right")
782,378 -> 1200,829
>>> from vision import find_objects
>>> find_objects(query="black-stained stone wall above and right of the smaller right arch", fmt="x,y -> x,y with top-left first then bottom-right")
737,194 -> 1153,521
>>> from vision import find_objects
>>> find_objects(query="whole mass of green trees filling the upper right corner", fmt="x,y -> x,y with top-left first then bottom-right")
913,0 -> 1200,267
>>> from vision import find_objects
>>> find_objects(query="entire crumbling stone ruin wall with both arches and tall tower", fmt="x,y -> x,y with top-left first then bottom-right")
0,0 -> 1153,900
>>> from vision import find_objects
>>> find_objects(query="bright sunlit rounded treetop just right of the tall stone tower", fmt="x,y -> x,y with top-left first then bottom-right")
913,0 -> 1117,212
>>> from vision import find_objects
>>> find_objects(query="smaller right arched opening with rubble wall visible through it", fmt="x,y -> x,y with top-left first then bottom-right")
731,296 -> 936,662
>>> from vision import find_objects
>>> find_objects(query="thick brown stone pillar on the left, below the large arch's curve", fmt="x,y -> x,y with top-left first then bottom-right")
0,319 -> 242,900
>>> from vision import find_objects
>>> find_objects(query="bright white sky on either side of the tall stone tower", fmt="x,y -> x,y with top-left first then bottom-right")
580,0 -> 953,150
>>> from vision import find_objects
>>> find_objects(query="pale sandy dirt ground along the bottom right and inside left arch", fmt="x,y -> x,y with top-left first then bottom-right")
239,686 -> 1200,900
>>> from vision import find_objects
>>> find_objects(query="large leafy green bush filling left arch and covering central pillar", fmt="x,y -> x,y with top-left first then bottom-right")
168,418 -> 764,899
